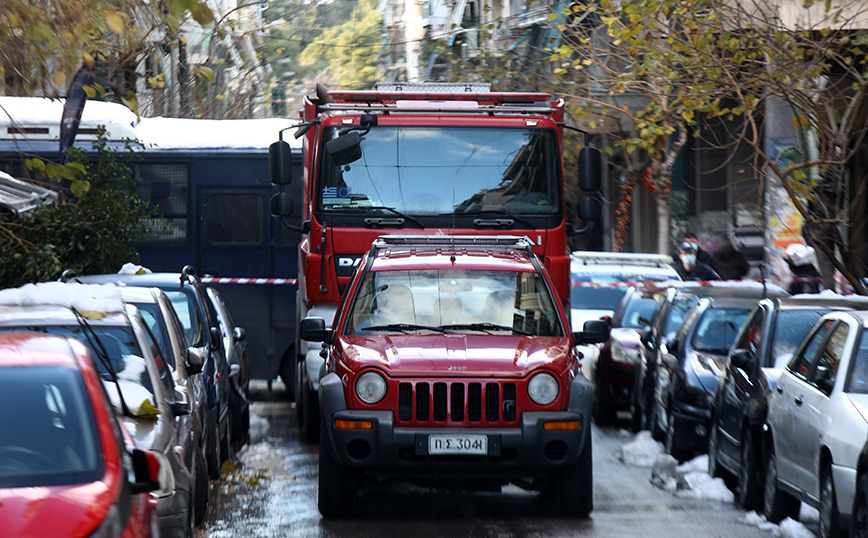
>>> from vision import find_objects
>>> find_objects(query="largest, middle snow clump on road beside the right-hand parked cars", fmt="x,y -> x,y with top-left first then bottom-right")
651,454 -> 735,502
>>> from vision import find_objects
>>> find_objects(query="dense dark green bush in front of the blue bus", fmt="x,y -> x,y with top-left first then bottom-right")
0,131 -> 149,287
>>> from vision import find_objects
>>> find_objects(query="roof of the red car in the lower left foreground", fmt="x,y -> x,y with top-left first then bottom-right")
0,331 -> 86,367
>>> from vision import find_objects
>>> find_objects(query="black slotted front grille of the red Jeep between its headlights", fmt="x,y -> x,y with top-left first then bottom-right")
398,381 -> 517,423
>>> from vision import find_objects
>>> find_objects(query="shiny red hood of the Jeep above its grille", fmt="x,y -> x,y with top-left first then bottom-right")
335,334 -> 571,378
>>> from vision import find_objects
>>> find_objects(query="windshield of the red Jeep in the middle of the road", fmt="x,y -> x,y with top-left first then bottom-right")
345,270 -> 564,336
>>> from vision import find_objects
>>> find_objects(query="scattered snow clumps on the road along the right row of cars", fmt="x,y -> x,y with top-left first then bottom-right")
617,430 -> 819,538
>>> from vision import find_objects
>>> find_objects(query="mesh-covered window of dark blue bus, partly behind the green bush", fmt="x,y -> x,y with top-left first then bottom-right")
134,163 -> 189,243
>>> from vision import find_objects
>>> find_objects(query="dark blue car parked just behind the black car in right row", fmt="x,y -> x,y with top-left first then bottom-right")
653,286 -> 786,461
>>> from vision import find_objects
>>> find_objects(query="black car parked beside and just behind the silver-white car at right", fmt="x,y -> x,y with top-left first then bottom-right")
708,294 -> 868,509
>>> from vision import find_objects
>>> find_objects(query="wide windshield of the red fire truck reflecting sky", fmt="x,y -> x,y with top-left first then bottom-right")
315,126 -> 563,216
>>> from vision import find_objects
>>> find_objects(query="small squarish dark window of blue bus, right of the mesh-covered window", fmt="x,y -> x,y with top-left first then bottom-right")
205,192 -> 262,245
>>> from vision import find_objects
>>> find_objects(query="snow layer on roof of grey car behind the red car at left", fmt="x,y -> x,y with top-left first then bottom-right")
0,282 -> 124,312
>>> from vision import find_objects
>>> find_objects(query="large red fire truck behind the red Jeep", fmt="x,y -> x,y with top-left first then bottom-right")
269,83 -> 602,441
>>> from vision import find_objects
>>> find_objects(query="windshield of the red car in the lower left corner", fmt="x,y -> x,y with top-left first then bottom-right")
0,366 -> 102,488
